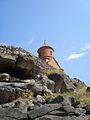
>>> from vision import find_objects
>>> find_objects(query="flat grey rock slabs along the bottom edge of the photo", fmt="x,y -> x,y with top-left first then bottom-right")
0,96 -> 90,120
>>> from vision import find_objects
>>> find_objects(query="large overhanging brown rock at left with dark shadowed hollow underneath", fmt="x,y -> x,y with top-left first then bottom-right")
0,46 -> 49,78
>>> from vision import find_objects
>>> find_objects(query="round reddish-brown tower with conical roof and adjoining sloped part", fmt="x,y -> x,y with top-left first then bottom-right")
37,40 -> 61,69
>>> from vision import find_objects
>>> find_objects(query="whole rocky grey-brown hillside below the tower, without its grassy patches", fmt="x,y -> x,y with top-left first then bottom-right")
0,46 -> 90,120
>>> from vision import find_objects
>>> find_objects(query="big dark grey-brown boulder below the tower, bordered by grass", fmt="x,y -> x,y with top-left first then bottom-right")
49,74 -> 76,93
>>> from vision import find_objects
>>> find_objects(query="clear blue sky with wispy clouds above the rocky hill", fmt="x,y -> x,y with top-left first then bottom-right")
0,0 -> 90,85
